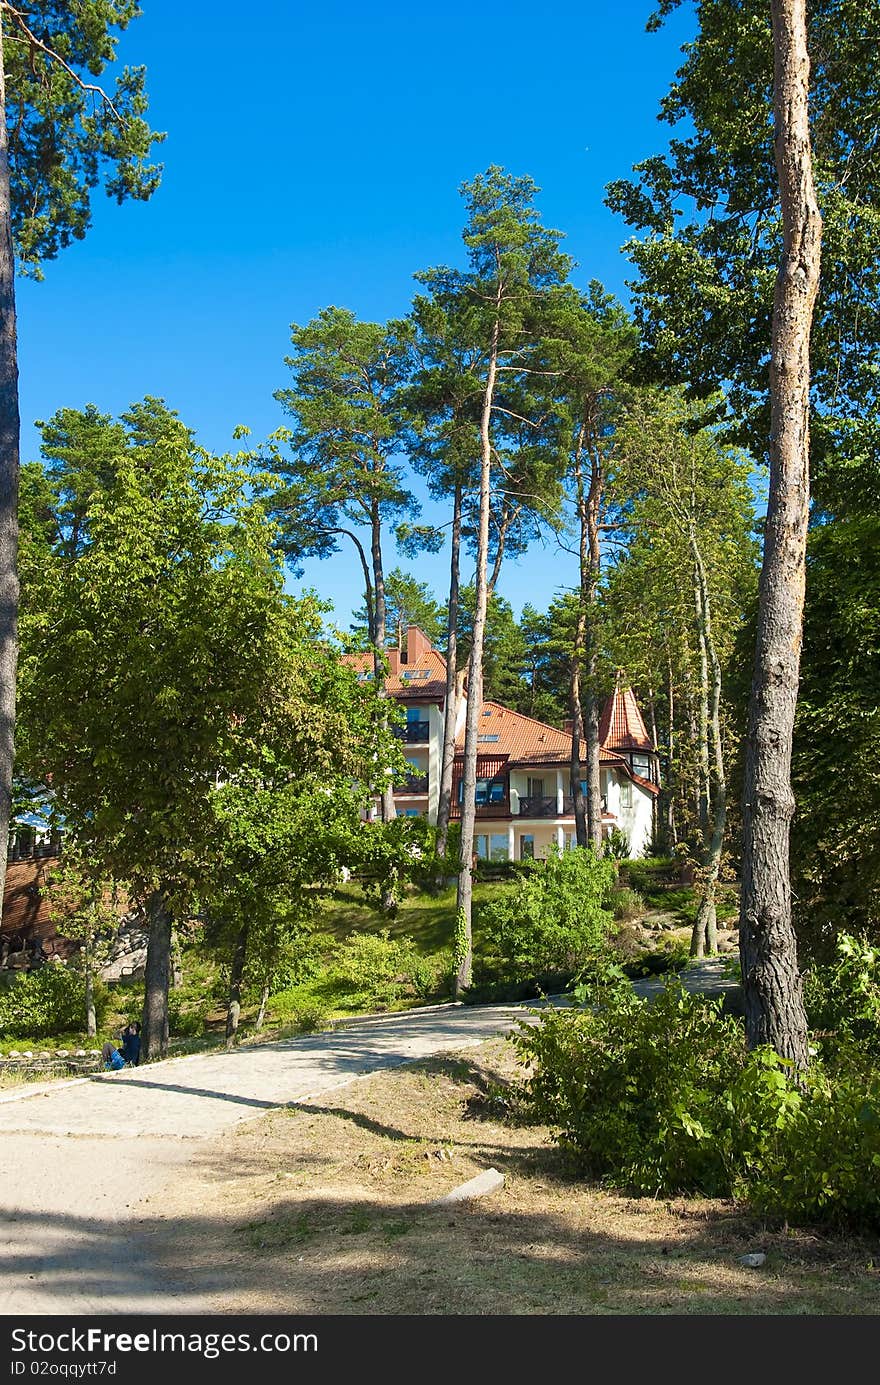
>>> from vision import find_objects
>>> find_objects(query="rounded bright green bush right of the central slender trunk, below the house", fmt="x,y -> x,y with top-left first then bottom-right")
478,848 -> 615,982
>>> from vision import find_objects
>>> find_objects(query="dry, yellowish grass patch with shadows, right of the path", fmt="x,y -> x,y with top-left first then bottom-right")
144,1040 -> 880,1314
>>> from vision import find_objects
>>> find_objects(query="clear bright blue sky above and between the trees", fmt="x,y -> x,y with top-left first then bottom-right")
18,0 -> 693,626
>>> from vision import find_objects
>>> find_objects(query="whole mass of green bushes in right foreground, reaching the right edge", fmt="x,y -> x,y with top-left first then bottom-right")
514,979 -> 880,1230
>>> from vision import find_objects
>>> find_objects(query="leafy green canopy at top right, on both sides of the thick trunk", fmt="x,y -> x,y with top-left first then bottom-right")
608,0 -> 880,510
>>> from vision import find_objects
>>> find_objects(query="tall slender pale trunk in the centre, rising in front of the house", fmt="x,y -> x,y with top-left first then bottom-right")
453,311 -> 500,999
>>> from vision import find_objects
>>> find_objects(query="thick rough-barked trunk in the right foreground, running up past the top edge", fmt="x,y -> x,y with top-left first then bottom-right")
740,0 -> 822,1072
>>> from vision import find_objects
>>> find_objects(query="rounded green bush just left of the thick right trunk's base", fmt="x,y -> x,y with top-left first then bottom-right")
516,981 -> 800,1197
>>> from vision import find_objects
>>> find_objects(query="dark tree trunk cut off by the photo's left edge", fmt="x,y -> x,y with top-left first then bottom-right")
0,15 -> 19,919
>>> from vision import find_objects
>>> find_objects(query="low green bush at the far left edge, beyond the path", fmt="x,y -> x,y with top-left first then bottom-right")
0,963 -> 108,1039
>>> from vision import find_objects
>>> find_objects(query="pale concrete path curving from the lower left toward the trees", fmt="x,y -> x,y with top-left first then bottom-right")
0,960 -> 734,1314
